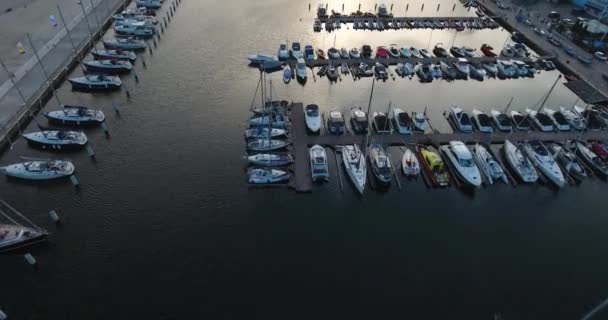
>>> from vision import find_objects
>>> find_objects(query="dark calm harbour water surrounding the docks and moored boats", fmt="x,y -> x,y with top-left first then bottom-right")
0,0 -> 608,319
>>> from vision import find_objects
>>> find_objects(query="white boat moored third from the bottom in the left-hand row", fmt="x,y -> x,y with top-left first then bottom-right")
23,129 -> 88,151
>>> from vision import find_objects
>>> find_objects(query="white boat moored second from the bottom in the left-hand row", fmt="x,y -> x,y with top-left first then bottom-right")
0,159 -> 74,180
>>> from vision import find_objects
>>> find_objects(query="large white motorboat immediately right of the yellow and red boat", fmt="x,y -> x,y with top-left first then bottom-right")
439,141 -> 481,188
